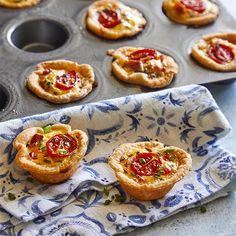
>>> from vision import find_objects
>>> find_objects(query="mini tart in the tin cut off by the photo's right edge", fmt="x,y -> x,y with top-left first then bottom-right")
192,33 -> 236,72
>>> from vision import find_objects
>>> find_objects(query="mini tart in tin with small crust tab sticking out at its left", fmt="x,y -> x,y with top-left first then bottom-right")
108,47 -> 178,88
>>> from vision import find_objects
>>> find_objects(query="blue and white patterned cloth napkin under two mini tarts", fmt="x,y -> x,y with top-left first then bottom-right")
0,85 -> 236,235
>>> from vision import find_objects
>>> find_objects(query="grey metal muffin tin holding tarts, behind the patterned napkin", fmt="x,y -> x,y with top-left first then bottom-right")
0,0 -> 236,121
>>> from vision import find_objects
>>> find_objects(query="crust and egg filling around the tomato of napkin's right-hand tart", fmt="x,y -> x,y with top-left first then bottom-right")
108,142 -> 192,200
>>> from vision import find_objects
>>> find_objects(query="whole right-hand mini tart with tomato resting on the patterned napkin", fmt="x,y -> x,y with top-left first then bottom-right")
108,142 -> 192,200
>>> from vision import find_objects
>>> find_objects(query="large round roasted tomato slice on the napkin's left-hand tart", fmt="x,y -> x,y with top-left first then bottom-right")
46,134 -> 77,158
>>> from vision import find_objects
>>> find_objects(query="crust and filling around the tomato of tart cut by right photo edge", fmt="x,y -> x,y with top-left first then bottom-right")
192,33 -> 236,72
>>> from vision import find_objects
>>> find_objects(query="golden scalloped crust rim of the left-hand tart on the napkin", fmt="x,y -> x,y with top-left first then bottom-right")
13,124 -> 88,183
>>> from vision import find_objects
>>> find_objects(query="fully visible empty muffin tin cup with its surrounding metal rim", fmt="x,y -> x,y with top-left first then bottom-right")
3,14 -> 82,61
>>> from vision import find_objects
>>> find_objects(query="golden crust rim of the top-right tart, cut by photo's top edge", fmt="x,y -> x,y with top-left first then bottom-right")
162,0 -> 219,26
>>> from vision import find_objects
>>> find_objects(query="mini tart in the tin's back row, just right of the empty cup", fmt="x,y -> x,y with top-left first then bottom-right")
86,0 -> 146,40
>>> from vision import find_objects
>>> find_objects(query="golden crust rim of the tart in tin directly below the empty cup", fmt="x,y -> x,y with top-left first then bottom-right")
26,60 -> 95,104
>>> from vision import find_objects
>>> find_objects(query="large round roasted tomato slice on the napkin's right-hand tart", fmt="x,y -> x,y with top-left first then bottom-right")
131,153 -> 161,176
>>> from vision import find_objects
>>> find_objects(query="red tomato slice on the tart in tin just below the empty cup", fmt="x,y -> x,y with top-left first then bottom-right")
56,70 -> 79,90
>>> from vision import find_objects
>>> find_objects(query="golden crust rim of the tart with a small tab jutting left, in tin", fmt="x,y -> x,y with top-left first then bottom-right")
109,47 -> 179,88
